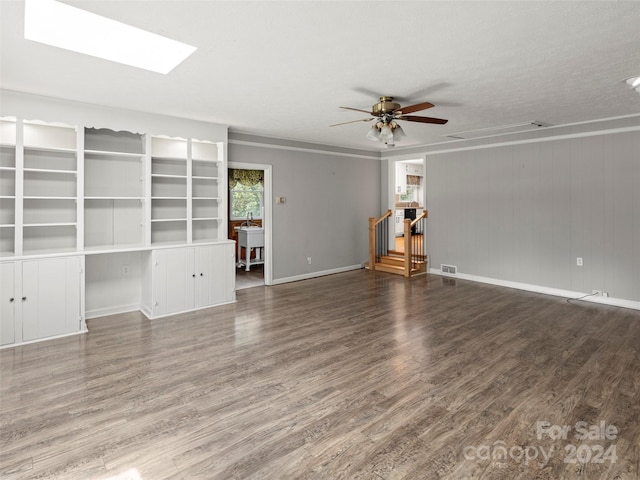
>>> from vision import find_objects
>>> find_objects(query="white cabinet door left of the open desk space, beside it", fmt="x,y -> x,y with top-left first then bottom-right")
21,257 -> 82,341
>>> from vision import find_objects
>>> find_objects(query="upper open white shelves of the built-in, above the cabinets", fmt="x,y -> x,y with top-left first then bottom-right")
0,122 -> 226,257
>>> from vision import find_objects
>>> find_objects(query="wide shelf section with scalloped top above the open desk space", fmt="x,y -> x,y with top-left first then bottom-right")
84,128 -> 146,250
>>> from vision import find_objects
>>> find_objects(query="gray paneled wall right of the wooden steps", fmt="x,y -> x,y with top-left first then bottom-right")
426,131 -> 640,301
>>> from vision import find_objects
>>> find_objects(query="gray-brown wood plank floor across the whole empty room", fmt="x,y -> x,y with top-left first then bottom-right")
0,270 -> 640,480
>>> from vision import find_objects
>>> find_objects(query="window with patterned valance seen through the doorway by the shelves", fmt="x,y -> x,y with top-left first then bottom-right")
229,169 -> 264,220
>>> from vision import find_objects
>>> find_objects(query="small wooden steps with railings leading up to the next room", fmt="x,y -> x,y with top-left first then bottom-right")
367,210 -> 428,277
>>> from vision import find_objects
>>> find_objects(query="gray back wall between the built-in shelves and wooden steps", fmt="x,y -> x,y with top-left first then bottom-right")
228,143 -> 380,282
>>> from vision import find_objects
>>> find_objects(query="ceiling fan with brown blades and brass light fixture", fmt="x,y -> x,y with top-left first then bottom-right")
330,96 -> 448,147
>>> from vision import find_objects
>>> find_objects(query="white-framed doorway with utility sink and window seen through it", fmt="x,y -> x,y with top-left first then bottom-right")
227,162 -> 273,290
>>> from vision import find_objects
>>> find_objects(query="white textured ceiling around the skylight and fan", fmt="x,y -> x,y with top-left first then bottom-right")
0,0 -> 640,150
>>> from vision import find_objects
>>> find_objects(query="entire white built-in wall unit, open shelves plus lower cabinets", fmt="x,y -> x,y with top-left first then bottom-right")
0,109 -> 235,347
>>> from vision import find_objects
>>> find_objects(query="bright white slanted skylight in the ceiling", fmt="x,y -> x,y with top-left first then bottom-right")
24,0 -> 196,74
